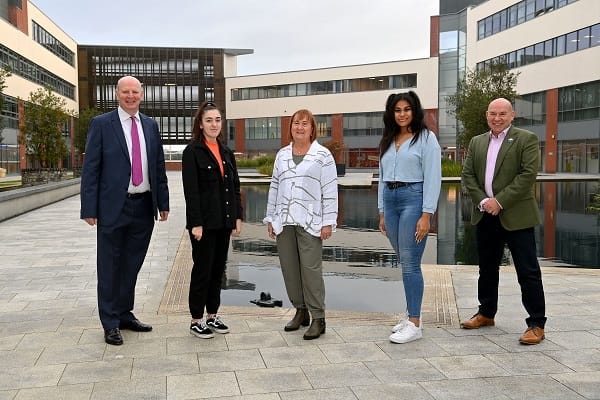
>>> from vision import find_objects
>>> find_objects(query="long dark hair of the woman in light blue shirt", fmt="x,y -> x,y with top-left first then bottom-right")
379,90 -> 427,154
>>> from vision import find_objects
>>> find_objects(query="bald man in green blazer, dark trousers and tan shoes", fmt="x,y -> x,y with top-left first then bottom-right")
461,98 -> 546,344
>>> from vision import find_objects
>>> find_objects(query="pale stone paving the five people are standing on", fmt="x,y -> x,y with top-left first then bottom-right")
0,172 -> 600,400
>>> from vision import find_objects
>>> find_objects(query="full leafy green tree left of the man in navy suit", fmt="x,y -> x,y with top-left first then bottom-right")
20,87 -> 69,168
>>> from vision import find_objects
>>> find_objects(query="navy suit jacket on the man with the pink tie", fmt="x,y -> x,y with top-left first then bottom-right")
81,110 -> 169,226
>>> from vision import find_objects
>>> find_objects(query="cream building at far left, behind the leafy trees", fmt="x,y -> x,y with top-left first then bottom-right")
0,0 -> 79,173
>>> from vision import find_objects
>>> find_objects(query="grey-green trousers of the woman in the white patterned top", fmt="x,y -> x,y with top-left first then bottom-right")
277,225 -> 325,319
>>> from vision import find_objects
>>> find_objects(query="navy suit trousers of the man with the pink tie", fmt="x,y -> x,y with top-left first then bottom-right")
97,195 -> 154,329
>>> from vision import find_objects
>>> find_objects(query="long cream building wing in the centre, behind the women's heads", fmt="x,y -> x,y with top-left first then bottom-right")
225,57 -> 438,167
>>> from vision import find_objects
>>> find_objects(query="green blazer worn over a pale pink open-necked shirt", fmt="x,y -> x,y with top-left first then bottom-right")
462,126 -> 541,231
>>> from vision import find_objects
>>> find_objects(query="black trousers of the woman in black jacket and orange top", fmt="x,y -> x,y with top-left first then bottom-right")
188,229 -> 231,319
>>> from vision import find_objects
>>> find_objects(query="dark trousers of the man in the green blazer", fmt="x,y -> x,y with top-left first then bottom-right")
477,213 -> 546,328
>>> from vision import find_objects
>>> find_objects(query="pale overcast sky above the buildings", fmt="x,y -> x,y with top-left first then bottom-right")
32,0 -> 439,75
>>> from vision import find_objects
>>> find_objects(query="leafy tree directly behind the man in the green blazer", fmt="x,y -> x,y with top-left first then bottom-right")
448,63 -> 519,147
